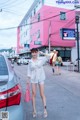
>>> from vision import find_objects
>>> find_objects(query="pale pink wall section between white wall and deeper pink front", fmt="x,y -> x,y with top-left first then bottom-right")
30,8 -> 44,48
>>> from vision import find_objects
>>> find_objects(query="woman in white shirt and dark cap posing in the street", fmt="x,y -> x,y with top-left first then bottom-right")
27,48 -> 48,117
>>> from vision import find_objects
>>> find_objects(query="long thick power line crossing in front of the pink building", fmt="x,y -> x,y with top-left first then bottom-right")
0,8 -> 77,30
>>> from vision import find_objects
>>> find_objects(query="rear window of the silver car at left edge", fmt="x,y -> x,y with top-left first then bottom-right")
0,55 -> 8,75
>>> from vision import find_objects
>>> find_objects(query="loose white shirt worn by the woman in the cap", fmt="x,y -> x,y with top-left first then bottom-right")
27,57 -> 48,83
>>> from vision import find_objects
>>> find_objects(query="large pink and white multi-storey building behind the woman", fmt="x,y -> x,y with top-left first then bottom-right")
17,1 -> 76,61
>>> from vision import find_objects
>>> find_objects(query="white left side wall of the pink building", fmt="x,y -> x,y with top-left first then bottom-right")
17,0 -> 42,52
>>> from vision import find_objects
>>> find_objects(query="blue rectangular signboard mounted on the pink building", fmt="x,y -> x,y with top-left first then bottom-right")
62,28 -> 75,40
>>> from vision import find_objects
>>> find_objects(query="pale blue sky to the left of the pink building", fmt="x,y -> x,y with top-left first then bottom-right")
0,0 -> 34,49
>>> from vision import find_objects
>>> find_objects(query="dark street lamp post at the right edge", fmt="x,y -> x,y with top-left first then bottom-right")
75,16 -> 80,72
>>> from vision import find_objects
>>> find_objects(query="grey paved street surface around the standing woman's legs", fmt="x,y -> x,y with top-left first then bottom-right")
14,65 -> 80,120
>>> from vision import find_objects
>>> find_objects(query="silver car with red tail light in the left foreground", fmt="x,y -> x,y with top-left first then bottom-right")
0,54 -> 24,120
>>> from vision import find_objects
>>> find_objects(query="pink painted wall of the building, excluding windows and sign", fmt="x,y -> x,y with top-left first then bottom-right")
30,6 -> 75,48
